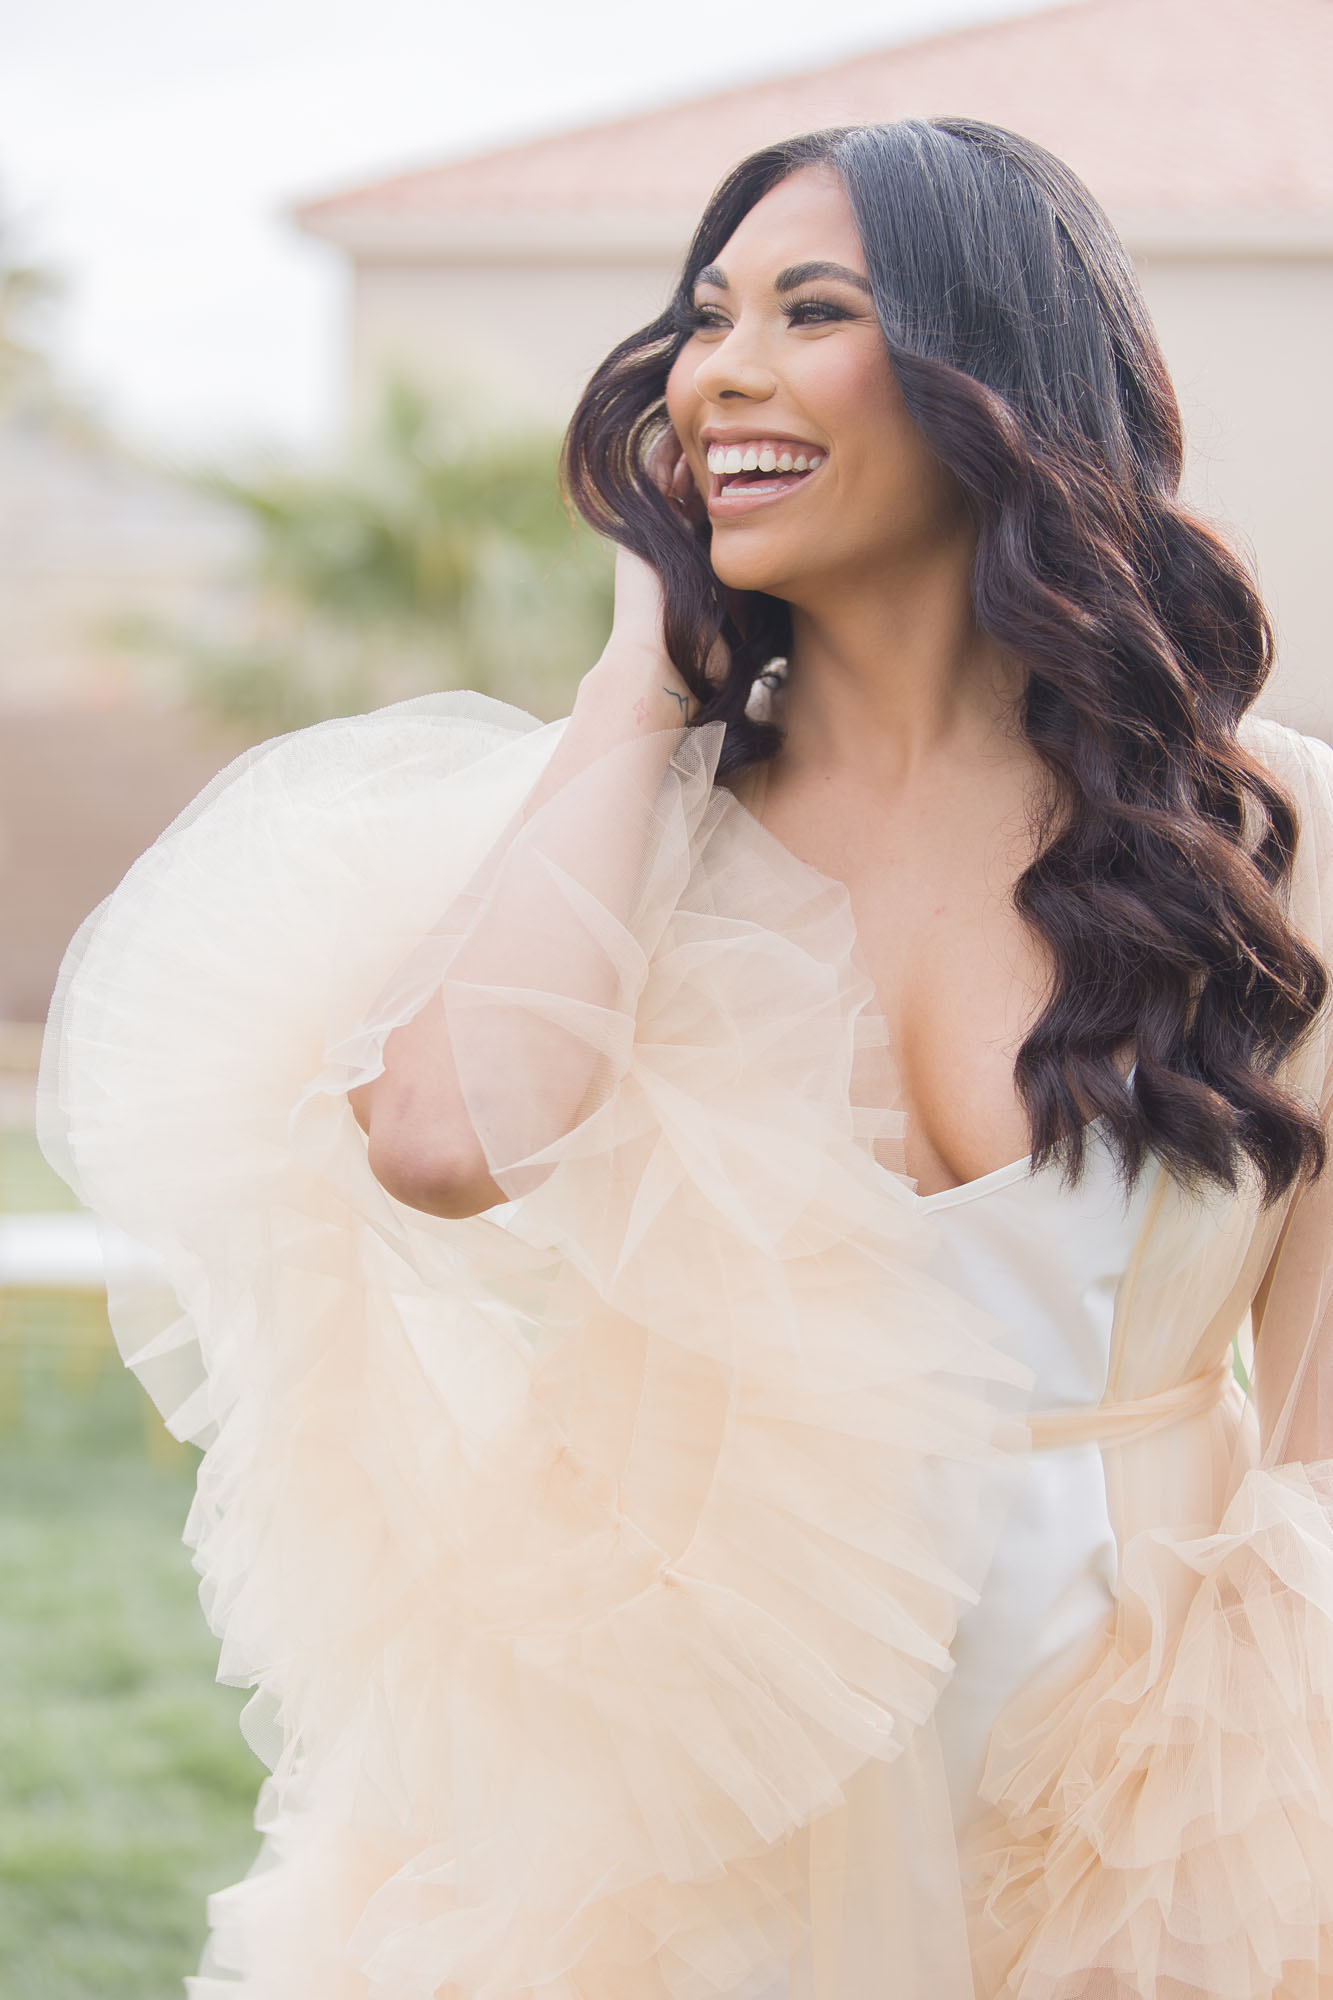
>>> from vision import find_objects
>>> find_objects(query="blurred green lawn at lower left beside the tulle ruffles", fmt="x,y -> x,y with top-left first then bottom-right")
0,1264 -> 262,2000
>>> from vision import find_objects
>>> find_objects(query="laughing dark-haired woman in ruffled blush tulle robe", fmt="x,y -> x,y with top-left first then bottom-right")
42,118 -> 1333,2000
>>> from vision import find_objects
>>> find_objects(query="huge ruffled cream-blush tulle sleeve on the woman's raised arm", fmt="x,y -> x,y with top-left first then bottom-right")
42,696 -> 1023,2000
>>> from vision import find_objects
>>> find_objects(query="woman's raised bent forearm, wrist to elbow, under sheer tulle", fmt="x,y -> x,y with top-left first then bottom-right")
350,644 -> 693,1216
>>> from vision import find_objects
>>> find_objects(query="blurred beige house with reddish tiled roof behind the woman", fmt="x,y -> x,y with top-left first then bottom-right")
298,0 -> 1333,736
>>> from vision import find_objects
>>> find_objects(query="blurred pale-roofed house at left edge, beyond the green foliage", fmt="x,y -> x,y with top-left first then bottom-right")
0,414 -> 246,1016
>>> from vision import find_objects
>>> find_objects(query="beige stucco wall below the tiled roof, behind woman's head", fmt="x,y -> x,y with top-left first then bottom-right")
350,250 -> 1333,738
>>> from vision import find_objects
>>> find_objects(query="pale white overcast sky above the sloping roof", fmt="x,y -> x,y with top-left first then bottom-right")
0,0 -> 1049,458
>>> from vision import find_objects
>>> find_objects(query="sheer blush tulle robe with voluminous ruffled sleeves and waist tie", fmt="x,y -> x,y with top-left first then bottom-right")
40,676 -> 1333,2000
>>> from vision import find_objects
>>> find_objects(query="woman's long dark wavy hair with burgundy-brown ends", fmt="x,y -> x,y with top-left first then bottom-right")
562,118 -> 1329,1200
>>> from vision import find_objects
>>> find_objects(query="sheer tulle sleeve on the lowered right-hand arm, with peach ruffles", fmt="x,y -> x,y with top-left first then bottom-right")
971,722 -> 1333,2000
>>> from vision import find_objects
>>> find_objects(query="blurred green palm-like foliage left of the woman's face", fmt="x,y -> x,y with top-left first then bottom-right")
122,378 -> 612,738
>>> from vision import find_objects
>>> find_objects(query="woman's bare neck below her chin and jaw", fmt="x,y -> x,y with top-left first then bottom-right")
783,548 -> 1025,782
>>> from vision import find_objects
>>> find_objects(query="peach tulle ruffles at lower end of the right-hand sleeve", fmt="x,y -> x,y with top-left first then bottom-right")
965,1462 -> 1333,2000
